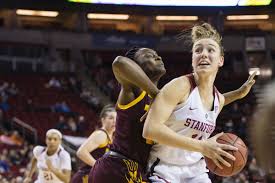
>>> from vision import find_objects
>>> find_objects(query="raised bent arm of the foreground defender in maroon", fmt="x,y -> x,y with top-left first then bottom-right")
112,56 -> 159,97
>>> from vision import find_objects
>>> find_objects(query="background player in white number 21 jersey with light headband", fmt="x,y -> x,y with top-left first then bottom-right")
24,129 -> 71,183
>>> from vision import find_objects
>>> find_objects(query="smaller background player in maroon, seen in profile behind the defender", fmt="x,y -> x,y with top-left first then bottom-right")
71,105 -> 116,183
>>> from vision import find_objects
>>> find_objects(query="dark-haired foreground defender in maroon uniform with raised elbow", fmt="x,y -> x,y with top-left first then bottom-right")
89,48 -> 166,183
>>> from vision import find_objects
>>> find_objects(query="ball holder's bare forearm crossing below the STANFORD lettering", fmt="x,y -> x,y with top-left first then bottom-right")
143,121 -> 203,152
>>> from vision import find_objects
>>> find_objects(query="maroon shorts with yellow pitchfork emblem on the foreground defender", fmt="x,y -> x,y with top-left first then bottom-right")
89,155 -> 149,183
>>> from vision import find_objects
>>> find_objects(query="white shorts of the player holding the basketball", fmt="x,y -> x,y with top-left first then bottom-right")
148,158 -> 211,183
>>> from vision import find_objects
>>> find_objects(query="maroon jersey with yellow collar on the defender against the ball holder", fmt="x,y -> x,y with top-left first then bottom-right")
110,91 -> 152,170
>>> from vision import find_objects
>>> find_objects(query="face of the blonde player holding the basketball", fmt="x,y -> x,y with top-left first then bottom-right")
192,38 -> 224,74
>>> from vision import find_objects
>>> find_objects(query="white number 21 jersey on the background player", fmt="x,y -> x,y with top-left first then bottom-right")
33,146 -> 72,183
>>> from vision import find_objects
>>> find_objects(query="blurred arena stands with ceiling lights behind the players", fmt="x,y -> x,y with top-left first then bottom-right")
0,0 -> 275,183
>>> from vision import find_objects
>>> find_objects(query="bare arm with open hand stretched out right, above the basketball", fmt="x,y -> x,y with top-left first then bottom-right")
223,72 -> 256,105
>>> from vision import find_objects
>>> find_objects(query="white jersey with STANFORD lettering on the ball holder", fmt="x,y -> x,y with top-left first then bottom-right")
150,75 -> 220,165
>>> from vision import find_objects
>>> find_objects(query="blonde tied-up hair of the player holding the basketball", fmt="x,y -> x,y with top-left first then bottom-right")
191,23 -> 224,56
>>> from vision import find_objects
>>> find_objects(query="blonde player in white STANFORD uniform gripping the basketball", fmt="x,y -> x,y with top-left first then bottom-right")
143,23 -> 255,183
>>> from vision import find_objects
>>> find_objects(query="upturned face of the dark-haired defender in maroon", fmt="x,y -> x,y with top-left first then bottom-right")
135,48 -> 166,79
